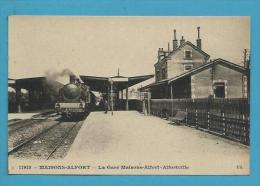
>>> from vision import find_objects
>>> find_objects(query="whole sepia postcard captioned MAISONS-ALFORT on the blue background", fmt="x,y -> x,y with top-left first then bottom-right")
6,16 -> 251,175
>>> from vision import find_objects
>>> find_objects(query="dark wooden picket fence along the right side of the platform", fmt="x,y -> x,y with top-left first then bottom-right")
137,98 -> 249,145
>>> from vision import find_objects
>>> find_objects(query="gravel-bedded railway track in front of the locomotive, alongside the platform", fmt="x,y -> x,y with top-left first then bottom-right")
8,121 -> 83,160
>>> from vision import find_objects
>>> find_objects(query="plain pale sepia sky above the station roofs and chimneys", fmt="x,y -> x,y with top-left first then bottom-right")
8,16 -> 250,82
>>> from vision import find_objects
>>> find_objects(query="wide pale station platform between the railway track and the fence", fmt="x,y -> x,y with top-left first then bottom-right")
65,111 -> 249,175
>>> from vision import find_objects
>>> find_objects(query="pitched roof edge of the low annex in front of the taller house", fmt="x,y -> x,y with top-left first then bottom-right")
168,58 -> 248,83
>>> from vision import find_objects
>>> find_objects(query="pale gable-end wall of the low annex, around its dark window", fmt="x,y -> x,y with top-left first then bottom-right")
191,64 -> 245,98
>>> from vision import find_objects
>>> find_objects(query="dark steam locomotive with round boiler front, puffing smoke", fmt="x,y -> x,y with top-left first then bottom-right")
55,75 -> 95,119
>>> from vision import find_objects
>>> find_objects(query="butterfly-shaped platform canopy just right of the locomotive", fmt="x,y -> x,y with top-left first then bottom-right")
80,75 -> 154,92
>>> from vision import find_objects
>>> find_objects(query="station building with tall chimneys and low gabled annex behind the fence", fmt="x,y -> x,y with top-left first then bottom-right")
141,27 -> 249,99
